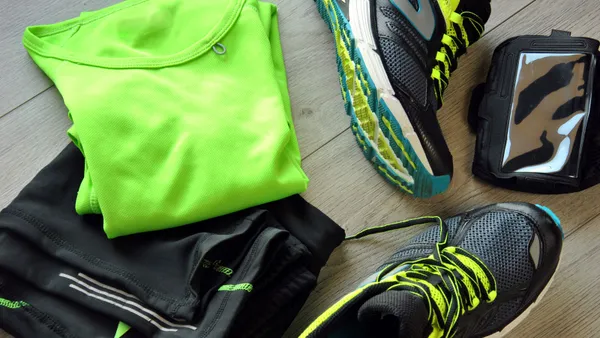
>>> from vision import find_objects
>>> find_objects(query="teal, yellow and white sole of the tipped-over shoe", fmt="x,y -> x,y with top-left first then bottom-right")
315,0 -> 451,198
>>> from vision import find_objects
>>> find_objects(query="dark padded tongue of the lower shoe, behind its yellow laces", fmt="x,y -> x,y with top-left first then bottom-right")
358,291 -> 429,337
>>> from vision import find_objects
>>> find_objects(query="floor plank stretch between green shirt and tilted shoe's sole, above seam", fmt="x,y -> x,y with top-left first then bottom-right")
270,0 -> 348,156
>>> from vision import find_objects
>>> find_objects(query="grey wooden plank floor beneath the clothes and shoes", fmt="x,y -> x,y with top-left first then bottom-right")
0,0 -> 600,338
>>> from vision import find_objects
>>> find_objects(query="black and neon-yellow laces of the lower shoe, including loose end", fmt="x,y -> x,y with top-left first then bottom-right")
346,216 -> 497,338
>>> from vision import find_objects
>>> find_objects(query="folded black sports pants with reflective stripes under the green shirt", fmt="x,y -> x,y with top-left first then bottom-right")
0,145 -> 344,338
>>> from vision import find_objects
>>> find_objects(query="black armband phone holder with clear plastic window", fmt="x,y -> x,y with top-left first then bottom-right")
469,31 -> 600,194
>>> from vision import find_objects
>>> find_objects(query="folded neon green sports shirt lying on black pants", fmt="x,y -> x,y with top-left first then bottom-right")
23,0 -> 308,238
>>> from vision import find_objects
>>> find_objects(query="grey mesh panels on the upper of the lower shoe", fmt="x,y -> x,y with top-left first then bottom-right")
384,210 -> 535,336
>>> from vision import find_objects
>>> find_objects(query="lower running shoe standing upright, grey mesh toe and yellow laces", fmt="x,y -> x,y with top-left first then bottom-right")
300,203 -> 563,338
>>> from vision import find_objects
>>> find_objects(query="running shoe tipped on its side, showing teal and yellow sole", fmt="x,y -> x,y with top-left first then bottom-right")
316,0 -> 490,198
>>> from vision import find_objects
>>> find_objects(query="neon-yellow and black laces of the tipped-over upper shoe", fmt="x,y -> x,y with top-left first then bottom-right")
431,12 -> 483,106
